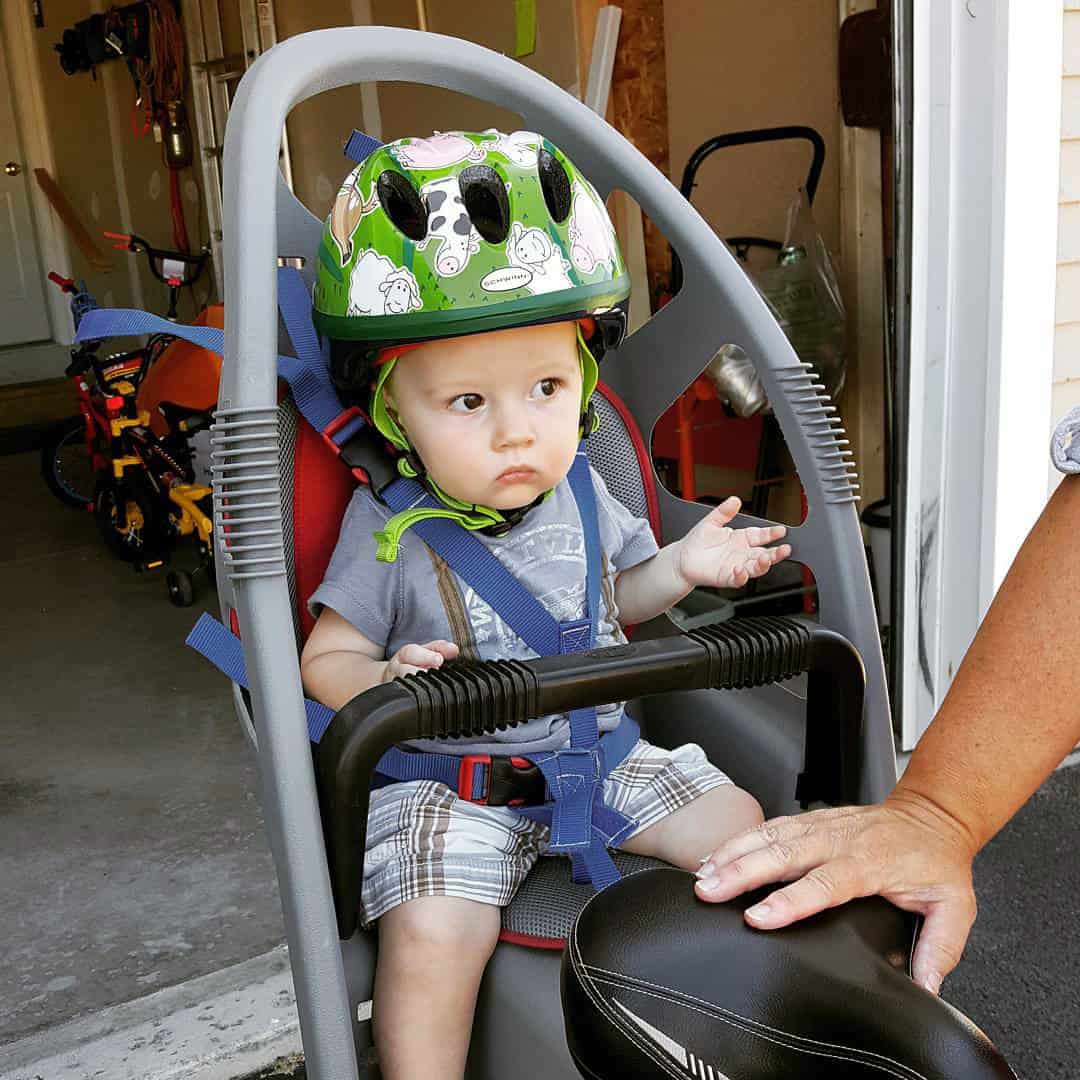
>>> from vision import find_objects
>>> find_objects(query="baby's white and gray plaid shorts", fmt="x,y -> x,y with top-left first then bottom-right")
361,739 -> 731,926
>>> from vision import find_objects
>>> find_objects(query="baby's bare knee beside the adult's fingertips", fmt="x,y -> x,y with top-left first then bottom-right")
621,784 -> 765,870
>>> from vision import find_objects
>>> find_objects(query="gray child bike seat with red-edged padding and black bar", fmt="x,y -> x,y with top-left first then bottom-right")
214,27 -> 1010,1080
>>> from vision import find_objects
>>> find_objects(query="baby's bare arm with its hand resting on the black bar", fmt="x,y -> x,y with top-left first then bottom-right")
300,607 -> 458,710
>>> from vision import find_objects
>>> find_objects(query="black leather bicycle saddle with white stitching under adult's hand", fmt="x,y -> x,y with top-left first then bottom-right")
563,868 -> 1015,1080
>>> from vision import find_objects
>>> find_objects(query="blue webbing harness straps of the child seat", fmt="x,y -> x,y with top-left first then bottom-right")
90,272 -> 637,889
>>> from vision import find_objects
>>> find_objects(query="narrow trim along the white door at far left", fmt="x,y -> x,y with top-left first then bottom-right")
0,3 -> 72,345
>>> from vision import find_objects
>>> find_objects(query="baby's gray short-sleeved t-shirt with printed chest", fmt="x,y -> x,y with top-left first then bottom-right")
308,470 -> 657,754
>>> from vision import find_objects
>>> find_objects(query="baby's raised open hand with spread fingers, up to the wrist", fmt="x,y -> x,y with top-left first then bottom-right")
677,496 -> 792,589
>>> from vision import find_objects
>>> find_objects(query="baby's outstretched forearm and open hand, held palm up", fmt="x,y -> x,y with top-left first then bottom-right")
615,496 -> 792,623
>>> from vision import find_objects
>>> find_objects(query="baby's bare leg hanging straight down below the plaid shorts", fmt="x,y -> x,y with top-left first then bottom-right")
373,894 -> 501,1080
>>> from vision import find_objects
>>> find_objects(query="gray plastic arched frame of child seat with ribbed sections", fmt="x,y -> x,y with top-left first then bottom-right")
215,27 -> 894,1080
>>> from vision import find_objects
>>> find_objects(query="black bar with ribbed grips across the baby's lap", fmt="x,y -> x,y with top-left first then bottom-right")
314,618 -> 866,939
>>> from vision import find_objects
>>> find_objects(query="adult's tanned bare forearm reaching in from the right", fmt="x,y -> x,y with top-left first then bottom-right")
894,476 -> 1080,850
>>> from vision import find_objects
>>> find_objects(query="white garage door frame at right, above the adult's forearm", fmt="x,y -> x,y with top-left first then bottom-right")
900,0 -> 1063,750
